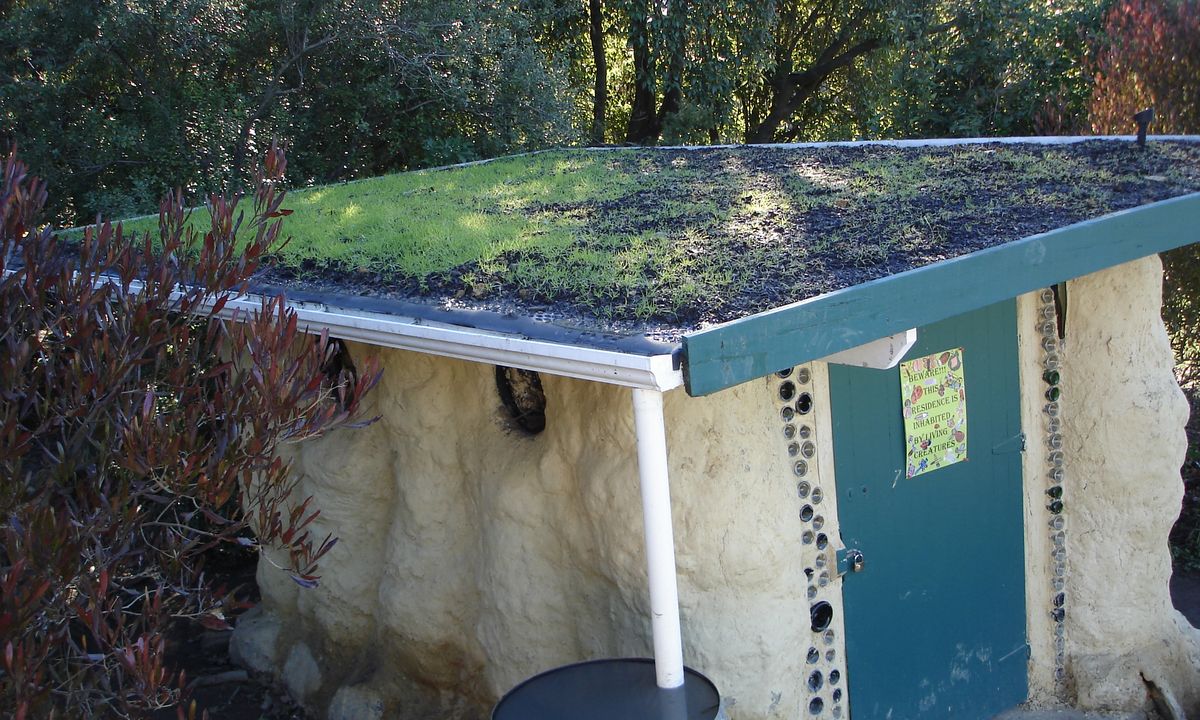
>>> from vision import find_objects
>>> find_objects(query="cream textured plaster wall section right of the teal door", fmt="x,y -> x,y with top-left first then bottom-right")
1060,257 -> 1200,718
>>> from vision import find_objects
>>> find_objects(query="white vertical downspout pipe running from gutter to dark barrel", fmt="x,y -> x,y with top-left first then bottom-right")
634,388 -> 683,689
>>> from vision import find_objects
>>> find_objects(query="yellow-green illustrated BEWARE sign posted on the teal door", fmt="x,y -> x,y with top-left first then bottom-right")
900,348 -> 967,478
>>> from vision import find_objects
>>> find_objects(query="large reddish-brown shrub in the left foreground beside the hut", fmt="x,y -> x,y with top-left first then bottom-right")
0,148 -> 378,719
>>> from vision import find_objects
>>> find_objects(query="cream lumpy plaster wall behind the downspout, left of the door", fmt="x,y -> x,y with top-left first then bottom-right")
233,344 -> 816,719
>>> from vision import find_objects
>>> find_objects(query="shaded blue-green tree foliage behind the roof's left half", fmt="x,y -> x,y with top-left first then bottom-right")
0,0 -> 570,223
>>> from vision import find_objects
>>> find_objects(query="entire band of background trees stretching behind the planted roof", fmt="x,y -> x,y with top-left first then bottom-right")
0,0 -> 1198,224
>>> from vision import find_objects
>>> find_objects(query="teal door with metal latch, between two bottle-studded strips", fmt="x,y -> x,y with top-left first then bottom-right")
829,301 -> 1028,720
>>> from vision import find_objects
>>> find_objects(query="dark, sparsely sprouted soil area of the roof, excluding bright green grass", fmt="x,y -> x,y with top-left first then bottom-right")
262,140 -> 1200,341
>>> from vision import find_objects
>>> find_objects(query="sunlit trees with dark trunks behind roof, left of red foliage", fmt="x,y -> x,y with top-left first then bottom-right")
544,0 -> 1102,143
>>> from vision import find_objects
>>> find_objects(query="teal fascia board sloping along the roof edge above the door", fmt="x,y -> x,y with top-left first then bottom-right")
683,193 -> 1200,396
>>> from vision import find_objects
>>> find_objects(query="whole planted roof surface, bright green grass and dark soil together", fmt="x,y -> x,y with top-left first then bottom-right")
110,143 -> 1200,322
